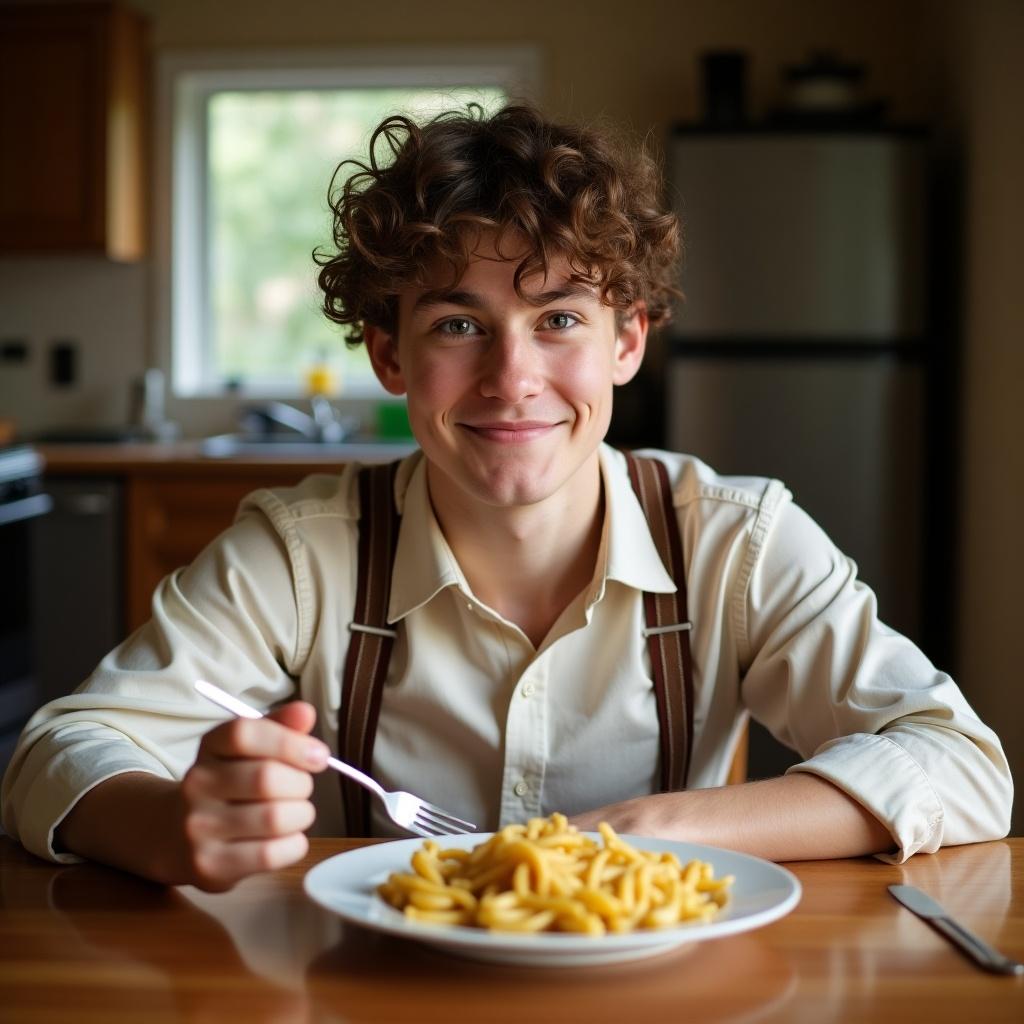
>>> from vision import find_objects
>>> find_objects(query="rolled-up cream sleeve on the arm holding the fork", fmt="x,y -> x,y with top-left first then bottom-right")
2,509 -> 304,862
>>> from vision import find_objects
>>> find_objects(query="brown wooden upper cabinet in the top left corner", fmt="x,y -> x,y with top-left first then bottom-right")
0,3 -> 146,261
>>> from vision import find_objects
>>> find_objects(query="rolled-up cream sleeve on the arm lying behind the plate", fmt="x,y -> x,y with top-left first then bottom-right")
737,491 -> 1013,863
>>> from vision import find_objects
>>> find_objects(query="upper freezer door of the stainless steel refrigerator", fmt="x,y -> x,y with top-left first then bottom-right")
669,133 -> 926,340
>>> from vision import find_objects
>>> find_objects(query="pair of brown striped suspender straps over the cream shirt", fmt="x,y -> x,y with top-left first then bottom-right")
338,453 -> 693,836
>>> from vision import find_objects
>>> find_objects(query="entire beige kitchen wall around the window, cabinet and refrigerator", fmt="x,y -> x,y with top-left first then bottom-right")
0,0 -> 1024,833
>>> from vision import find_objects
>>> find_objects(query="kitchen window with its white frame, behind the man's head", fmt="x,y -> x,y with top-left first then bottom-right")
156,48 -> 537,399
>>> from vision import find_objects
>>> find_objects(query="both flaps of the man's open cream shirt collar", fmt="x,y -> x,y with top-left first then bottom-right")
387,444 -> 676,623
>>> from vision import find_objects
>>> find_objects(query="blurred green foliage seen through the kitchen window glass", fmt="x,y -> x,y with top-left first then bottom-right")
206,87 -> 505,391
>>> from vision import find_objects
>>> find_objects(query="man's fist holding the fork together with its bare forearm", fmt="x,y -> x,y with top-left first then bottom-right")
56,701 -> 329,892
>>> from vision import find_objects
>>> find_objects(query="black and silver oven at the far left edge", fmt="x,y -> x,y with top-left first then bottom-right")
0,444 -> 52,772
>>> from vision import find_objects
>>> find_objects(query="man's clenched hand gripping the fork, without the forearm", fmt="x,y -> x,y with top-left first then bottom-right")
172,701 -> 330,891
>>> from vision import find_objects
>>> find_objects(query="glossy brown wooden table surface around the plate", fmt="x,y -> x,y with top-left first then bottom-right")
0,838 -> 1024,1024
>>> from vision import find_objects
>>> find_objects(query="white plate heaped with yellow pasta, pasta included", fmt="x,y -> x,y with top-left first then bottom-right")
304,814 -> 801,967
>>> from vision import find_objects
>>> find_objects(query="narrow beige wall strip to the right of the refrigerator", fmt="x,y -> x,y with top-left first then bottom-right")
941,0 -> 1024,836
